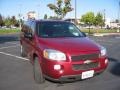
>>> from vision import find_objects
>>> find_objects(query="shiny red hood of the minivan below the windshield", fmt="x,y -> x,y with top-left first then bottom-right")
39,37 -> 99,52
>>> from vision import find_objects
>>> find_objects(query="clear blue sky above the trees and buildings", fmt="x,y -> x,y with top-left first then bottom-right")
0,0 -> 119,20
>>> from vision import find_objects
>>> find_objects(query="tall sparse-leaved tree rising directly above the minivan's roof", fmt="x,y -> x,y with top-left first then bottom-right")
47,0 -> 73,19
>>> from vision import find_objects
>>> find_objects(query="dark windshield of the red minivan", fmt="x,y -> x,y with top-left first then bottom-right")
38,22 -> 84,38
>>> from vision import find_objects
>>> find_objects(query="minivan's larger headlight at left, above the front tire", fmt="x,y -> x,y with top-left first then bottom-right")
43,49 -> 66,61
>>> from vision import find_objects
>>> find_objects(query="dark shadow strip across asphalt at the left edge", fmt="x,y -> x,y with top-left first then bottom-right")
0,34 -> 19,44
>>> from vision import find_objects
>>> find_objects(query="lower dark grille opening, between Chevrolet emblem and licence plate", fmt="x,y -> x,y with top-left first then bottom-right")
72,62 -> 99,70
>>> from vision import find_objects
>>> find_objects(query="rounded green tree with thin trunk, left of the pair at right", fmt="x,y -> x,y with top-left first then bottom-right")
81,12 -> 95,33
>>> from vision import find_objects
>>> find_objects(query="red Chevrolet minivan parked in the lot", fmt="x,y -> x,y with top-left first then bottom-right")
20,20 -> 108,83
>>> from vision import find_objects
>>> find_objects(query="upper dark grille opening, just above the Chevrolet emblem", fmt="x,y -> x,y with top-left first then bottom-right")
71,53 -> 99,61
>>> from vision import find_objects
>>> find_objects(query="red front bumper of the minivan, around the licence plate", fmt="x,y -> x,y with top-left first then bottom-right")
42,57 -> 108,82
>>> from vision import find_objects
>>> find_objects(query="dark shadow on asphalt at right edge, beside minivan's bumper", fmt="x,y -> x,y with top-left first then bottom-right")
109,58 -> 120,76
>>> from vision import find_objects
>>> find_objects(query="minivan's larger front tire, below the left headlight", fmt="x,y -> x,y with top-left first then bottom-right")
33,57 -> 45,84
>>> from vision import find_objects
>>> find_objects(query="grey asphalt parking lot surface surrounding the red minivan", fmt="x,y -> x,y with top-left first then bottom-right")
0,35 -> 120,90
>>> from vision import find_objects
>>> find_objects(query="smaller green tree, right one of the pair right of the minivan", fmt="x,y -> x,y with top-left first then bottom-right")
94,13 -> 104,27
